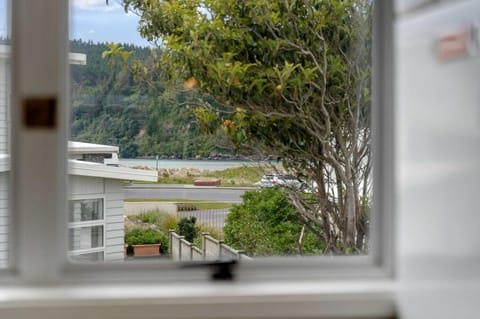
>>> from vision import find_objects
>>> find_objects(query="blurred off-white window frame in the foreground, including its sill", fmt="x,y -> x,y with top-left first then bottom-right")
0,0 -> 395,318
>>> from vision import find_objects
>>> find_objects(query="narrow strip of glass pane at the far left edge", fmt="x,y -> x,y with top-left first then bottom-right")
0,0 -> 11,268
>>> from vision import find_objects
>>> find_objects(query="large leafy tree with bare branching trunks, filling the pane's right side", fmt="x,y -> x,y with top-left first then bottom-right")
119,0 -> 371,252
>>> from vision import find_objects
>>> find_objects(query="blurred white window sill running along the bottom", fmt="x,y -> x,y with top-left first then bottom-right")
0,280 -> 395,319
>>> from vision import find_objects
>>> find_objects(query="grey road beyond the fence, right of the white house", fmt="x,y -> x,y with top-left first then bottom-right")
125,184 -> 255,203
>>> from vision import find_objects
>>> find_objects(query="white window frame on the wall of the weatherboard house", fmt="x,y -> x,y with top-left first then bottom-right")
68,194 -> 107,260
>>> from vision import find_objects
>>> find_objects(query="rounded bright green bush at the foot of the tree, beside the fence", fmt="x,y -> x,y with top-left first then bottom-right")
224,188 -> 324,256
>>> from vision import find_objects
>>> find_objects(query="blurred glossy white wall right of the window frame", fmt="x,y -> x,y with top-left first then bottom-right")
395,1 -> 480,318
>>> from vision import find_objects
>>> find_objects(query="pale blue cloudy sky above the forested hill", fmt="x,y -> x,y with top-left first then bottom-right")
0,0 -> 150,46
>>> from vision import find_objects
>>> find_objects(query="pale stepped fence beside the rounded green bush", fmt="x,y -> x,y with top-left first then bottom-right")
170,230 -> 251,261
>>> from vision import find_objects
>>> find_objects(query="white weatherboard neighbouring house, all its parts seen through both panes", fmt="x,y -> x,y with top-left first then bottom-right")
0,45 -> 157,267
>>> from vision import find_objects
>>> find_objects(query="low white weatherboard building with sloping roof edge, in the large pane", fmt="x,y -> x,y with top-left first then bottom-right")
68,142 -> 157,261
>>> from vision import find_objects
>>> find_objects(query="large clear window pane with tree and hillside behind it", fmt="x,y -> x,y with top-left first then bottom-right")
69,0 -> 373,261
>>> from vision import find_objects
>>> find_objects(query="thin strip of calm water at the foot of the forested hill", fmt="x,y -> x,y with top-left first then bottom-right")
119,158 -> 259,170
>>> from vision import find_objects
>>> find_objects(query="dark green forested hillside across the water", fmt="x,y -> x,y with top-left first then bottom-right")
70,40 -> 229,158
